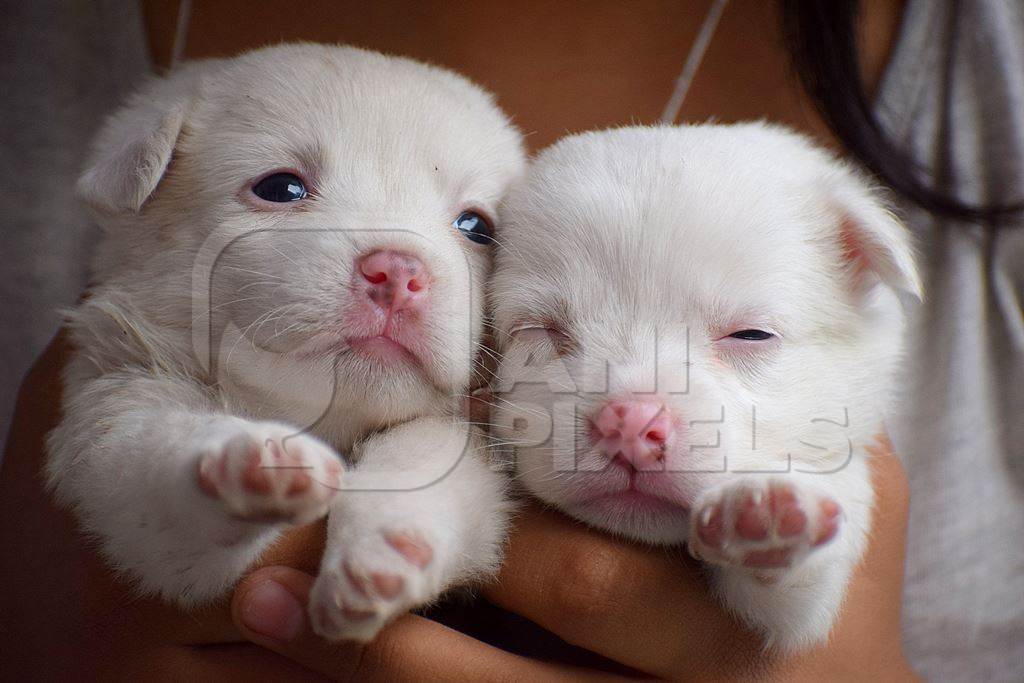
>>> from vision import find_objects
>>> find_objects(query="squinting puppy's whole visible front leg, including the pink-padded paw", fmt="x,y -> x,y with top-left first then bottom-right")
688,460 -> 872,652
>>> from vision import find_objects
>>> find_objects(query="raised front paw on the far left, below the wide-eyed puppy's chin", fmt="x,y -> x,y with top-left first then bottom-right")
196,423 -> 342,524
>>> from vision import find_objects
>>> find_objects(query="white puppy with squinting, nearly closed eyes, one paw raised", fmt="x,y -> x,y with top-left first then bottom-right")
490,123 -> 920,651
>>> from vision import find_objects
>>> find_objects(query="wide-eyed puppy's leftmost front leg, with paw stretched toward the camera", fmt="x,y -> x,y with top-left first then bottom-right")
47,372 -> 341,605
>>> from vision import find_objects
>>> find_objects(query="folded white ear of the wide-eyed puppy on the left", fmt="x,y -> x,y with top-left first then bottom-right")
77,74 -> 195,213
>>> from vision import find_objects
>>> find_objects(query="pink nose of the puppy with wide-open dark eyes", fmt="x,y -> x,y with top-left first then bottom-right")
355,251 -> 430,310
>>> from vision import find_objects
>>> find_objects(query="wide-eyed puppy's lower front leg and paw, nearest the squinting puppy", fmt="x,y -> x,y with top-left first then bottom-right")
309,418 -> 510,641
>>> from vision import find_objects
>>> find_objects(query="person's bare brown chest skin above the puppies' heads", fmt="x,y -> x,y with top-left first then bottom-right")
142,0 -> 903,151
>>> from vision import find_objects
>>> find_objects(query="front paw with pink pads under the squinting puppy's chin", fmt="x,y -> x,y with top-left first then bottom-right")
687,478 -> 842,572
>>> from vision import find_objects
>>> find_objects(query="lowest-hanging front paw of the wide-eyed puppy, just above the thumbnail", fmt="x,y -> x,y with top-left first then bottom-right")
309,528 -> 443,642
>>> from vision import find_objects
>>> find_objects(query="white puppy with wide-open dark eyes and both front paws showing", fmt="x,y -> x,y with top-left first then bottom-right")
47,44 -> 524,640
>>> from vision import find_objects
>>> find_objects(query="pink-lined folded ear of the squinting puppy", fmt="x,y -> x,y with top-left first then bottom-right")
831,173 -> 923,299
